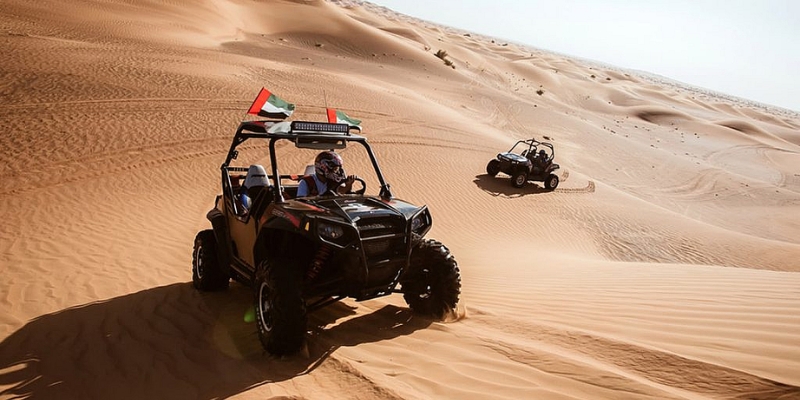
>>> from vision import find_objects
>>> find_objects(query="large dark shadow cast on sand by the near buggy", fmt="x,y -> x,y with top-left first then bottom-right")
0,283 -> 431,399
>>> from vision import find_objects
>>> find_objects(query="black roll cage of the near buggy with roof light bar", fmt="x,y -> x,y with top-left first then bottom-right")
220,121 -> 394,203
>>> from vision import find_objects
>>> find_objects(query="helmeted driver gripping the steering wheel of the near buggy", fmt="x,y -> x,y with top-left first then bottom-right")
297,151 -> 358,197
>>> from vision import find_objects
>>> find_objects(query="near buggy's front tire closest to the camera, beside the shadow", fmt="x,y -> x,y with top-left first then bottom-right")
255,257 -> 307,356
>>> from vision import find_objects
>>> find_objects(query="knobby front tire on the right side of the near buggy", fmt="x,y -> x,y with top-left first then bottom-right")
401,239 -> 461,319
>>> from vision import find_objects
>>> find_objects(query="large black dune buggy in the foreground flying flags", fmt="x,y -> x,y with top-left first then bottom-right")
192,121 -> 461,355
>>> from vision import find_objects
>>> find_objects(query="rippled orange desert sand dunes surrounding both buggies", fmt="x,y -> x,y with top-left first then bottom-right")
0,0 -> 800,399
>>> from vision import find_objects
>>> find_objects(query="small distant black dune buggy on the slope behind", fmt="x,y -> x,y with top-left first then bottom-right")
486,139 -> 560,190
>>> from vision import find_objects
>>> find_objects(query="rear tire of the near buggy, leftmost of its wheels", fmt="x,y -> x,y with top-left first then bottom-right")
192,229 -> 230,290
